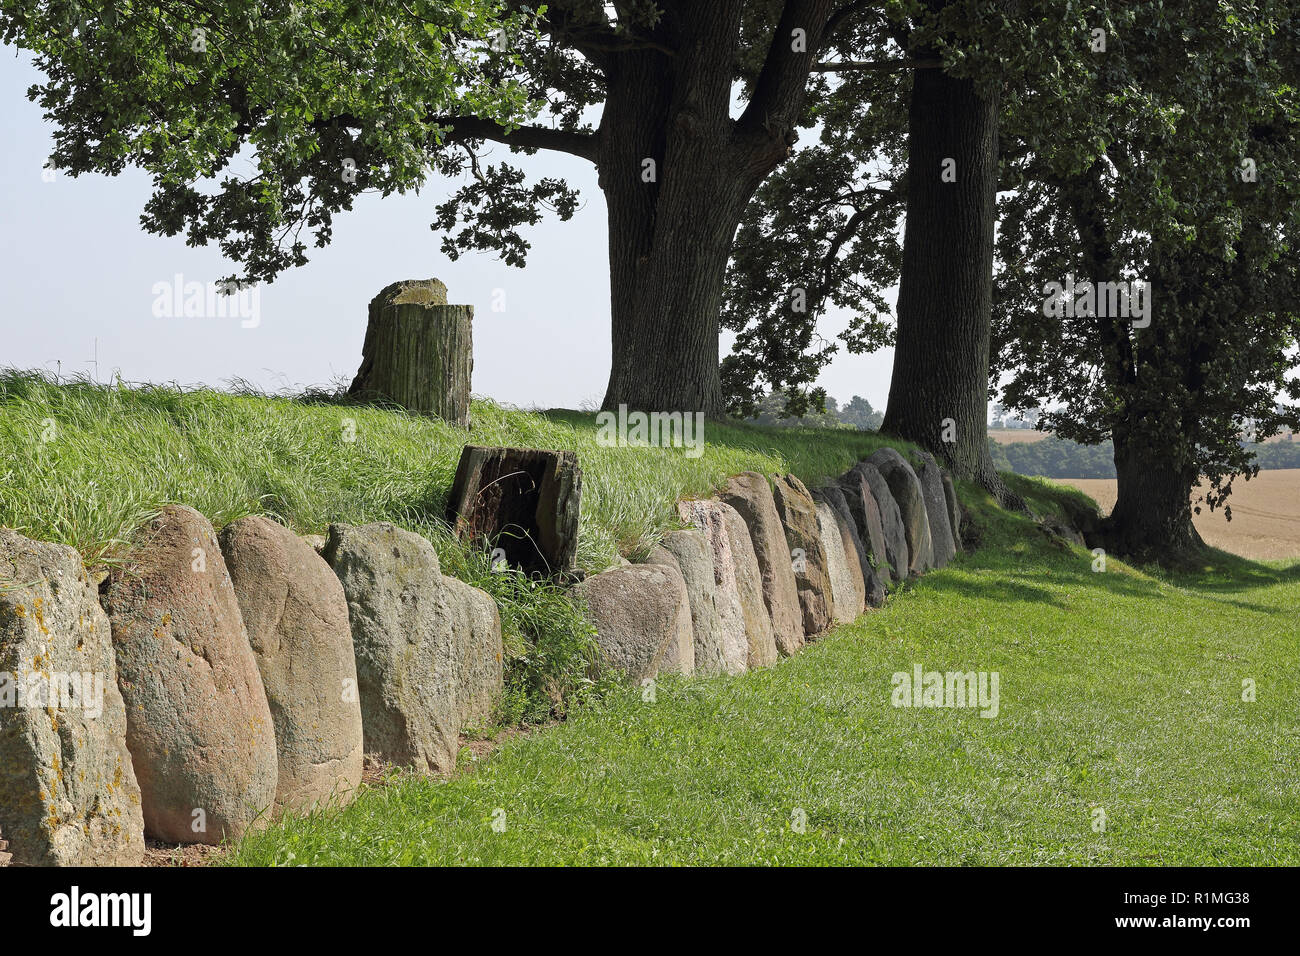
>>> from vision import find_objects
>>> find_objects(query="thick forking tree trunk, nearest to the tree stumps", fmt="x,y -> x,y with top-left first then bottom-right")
597,0 -> 800,416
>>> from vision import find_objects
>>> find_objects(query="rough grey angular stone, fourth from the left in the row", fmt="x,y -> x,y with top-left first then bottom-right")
322,523 -> 460,773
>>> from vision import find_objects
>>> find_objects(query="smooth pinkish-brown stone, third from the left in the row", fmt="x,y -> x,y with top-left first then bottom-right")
220,515 -> 365,813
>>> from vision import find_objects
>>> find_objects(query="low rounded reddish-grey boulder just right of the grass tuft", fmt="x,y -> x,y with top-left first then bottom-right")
579,564 -> 694,683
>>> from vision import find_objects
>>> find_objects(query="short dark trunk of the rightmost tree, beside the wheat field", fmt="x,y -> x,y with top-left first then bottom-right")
1105,429 -> 1205,564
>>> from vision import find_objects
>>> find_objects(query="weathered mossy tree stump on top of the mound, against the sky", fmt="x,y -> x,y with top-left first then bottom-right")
348,278 -> 475,428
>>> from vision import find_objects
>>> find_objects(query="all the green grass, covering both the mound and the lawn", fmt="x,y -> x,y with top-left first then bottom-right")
0,373 -> 1300,865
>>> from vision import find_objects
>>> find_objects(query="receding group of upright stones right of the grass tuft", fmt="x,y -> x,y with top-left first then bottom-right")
579,447 -> 962,683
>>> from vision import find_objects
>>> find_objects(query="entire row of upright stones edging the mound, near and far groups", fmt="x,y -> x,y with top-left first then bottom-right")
0,446 -> 961,865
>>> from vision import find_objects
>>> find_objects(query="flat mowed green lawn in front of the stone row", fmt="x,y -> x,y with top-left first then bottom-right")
225,496 -> 1300,865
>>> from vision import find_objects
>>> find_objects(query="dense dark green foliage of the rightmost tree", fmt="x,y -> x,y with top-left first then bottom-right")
993,0 -> 1300,507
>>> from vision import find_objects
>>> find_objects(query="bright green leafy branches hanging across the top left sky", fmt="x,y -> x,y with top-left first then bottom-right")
0,0 -> 543,280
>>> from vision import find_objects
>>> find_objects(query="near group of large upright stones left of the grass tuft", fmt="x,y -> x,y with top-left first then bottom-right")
0,506 -> 502,865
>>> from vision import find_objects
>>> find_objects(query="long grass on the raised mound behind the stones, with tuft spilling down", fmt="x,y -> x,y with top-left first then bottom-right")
0,371 -> 904,723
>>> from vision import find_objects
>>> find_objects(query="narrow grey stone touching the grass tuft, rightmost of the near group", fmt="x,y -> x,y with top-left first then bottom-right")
442,576 -> 504,728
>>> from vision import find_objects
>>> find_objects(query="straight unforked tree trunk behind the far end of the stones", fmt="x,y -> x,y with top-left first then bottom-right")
881,35 -> 1017,505
